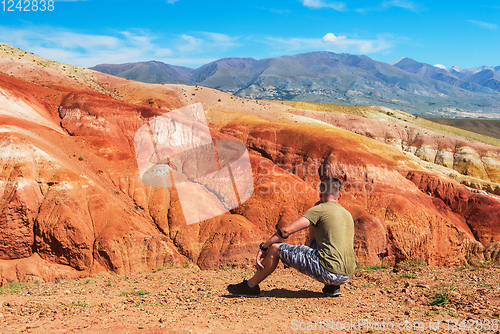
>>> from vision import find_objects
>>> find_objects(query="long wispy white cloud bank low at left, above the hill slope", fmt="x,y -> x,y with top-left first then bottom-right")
0,25 -> 240,67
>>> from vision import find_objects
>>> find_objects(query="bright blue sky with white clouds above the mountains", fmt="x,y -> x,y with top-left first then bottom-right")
0,0 -> 500,68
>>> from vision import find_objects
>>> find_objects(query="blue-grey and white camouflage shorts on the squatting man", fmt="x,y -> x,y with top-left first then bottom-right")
278,243 -> 349,285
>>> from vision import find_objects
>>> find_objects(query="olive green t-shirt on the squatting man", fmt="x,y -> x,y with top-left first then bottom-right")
303,202 -> 358,276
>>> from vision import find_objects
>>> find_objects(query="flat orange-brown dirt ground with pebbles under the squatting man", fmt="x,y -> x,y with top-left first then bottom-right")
0,267 -> 500,333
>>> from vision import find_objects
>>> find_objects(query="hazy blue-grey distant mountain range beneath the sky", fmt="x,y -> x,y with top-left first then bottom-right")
92,52 -> 500,118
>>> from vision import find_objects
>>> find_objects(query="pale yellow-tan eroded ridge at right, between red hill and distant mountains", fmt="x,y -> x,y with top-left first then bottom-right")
284,103 -> 500,195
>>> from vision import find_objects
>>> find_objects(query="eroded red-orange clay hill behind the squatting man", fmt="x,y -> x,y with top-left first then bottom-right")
0,44 -> 500,281
